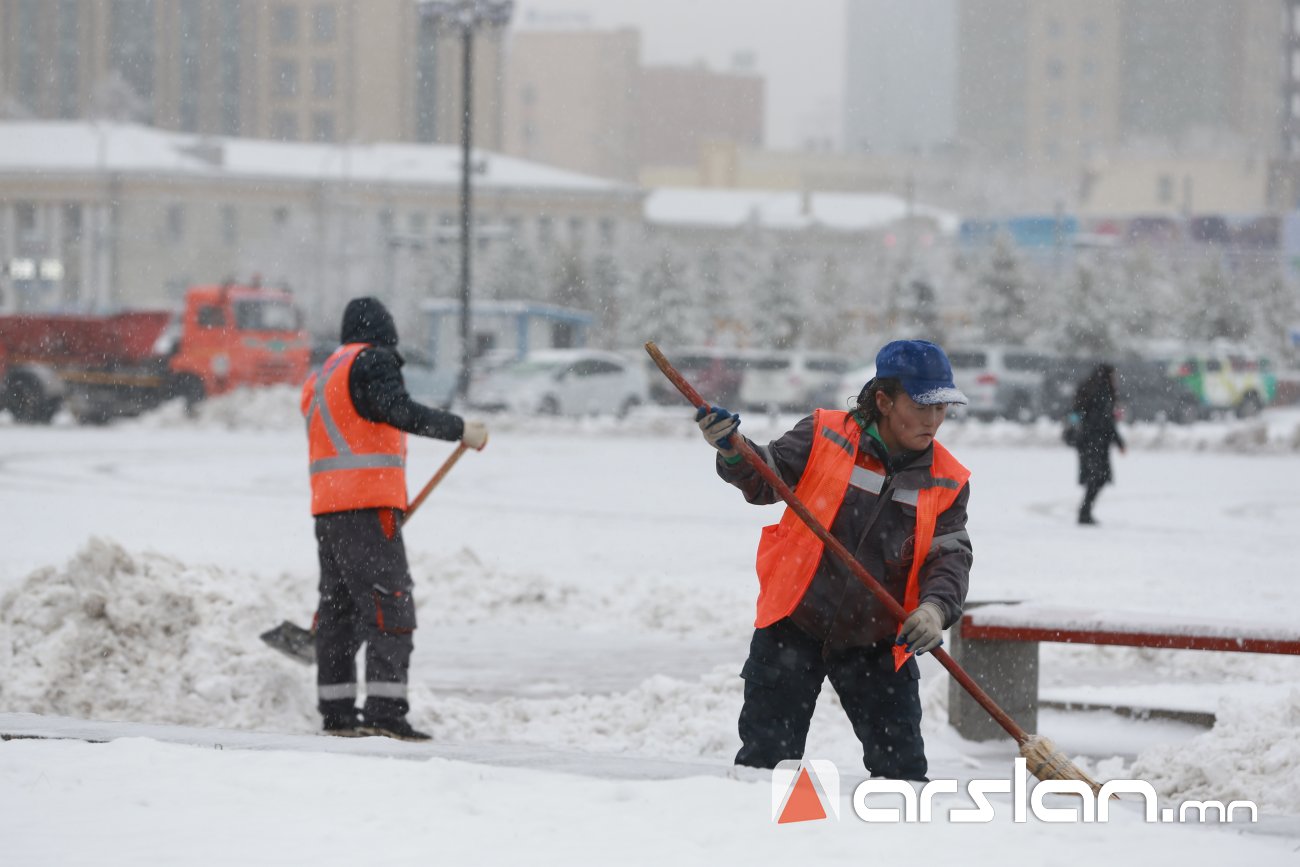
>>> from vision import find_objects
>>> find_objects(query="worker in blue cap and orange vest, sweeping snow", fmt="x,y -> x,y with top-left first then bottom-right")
697,341 -> 972,780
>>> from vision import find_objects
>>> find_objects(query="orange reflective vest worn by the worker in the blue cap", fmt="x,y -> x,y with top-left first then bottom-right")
754,409 -> 970,667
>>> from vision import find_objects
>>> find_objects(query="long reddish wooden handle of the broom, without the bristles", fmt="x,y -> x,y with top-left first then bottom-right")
646,342 -> 1030,744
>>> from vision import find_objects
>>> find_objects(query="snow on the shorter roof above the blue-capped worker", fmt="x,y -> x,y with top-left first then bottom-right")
645,187 -> 961,233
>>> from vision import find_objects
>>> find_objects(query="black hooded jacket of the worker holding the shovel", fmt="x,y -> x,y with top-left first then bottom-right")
341,298 -> 465,439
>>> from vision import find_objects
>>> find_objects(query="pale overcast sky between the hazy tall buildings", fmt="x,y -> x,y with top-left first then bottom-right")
515,0 -> 846,148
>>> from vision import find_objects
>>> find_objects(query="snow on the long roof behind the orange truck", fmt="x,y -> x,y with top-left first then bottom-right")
0,121 -> 634,192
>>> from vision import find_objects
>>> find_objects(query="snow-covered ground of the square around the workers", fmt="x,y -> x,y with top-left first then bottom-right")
0,390 -> 1300,866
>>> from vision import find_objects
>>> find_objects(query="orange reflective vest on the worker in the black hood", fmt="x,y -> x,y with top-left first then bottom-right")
302,343 -> 407,515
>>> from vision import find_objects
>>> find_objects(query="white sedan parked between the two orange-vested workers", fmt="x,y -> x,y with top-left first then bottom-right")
469,350 -> 649,417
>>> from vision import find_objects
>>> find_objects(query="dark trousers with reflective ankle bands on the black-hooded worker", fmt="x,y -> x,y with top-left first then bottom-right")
316,508 -> 415,721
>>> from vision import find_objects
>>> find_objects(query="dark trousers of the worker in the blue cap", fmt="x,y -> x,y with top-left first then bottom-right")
736,619 -> 927,780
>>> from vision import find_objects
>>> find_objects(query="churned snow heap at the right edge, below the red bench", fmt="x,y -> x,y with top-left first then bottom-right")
1132,686 -> 1300,814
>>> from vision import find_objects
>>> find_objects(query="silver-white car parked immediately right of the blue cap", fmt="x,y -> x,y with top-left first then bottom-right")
948,346 -> 1056,421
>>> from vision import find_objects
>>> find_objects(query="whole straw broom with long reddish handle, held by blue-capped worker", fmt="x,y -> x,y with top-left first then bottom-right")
646,342 -> 1101,794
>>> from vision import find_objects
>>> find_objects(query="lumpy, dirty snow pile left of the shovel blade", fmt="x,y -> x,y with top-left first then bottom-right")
0,539 -> 315,728
